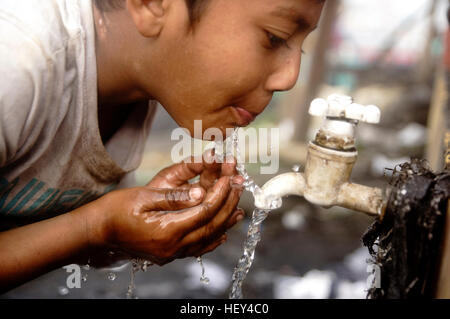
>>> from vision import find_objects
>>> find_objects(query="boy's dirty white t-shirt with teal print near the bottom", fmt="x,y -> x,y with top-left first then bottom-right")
0,0 -> 156,229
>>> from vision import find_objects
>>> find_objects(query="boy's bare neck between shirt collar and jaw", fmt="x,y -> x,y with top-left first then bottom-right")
93,5 -> 151,109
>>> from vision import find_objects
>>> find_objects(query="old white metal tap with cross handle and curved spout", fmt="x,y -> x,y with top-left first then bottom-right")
255,94 -> 384,215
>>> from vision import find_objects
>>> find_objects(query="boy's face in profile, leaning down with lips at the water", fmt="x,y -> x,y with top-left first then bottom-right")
141,0 -> 323,134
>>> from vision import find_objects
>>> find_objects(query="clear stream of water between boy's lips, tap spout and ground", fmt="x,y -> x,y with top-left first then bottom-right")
227,130 -> 281,299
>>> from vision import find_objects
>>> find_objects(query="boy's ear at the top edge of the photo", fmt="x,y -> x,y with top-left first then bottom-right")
127,0 -> 167,38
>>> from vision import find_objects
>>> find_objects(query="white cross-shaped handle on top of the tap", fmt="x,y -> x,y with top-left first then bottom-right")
309,94 -> 381,124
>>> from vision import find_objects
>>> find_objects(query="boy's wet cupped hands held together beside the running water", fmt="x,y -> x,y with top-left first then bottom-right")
85,151 -> 244,265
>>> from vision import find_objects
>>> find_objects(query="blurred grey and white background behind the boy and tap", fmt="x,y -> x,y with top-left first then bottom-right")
1,0 -> 449,298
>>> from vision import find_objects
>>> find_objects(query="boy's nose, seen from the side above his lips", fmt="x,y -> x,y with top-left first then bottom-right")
266,50 -> 302,92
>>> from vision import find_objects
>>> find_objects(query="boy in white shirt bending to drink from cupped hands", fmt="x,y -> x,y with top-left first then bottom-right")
0,0 -> 324,290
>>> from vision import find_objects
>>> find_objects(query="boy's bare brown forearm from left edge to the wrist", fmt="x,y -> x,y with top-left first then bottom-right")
0,206 -> 99,292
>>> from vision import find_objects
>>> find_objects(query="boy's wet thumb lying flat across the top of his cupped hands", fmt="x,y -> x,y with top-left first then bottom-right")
144,187 -> 205,211
